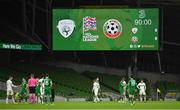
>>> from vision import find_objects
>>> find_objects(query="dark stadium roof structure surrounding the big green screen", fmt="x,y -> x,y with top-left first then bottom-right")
0,0 -> 180,73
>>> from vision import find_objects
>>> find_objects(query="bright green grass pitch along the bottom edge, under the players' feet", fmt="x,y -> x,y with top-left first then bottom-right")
0,101 -> 180,110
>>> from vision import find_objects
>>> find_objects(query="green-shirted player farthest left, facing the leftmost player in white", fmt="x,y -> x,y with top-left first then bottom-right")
20,78 -> 28,102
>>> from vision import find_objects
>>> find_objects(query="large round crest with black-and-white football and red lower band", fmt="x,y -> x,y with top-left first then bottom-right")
103,19 -> 122,39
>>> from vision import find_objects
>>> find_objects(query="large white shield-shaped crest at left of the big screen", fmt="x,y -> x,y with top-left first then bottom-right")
57,19 -> 75,38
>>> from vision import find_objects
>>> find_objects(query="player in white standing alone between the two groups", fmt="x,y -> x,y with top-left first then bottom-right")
92,78 -> 100,102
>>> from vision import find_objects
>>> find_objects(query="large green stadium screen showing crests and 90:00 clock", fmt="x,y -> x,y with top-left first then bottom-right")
52,8 -> 159,51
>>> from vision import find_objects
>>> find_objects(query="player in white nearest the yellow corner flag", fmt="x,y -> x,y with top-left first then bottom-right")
137,80 -> 146,102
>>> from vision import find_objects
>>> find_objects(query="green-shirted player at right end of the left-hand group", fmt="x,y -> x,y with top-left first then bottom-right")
43,75 -> 52,104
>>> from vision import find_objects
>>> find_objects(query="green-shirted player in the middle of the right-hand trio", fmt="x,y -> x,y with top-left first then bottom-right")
128,77 -> 137,104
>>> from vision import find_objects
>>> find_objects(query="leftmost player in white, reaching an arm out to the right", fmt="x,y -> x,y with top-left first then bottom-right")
6,76 -> 17,104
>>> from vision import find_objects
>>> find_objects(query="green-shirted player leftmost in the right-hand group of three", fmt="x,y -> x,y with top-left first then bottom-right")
119,77 -> 126,102
